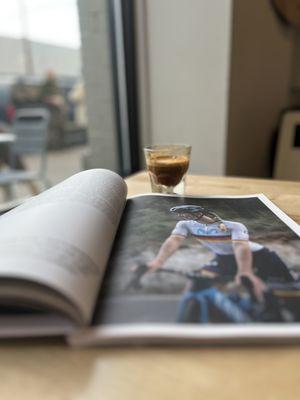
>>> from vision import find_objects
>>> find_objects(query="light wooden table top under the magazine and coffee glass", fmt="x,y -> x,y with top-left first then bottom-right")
0,173 -> 300,400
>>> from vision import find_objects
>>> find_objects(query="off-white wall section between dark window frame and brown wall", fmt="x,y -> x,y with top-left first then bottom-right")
139,0 -> 231,174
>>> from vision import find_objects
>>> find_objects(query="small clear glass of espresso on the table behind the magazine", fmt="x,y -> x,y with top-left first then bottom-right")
144,144 -> 191,194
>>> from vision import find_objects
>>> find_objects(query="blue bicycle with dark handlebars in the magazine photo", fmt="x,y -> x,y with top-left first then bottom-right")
125,264 -> 300,323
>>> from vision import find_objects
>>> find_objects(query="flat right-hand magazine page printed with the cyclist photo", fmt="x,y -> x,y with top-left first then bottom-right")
70,195 -> 300,345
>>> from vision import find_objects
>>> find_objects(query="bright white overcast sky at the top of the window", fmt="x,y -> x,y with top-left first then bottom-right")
0,0 -> 80,48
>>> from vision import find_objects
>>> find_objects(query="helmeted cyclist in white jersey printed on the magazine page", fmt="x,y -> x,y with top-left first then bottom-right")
147,205 -> 294,302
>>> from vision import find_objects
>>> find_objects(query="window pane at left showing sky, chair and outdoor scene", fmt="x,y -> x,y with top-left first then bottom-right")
0,0 -> 88,203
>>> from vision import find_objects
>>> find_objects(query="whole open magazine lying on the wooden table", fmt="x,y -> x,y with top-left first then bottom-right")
0,169 -> 300,345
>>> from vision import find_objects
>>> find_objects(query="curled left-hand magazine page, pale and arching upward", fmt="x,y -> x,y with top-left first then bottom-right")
0,169 -> 126,323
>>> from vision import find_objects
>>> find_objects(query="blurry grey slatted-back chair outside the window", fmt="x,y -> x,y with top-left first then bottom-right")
0,108 -> 50,200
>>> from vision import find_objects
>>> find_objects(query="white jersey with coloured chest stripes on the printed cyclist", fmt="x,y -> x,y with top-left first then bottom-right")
172,220 -> 263,255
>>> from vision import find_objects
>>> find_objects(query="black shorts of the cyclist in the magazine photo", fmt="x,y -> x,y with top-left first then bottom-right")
203,247 -> 294,283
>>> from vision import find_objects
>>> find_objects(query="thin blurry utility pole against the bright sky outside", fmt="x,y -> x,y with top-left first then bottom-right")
18,0 -> 34,75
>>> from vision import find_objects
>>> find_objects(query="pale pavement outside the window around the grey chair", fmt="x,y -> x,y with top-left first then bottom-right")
0,146 -> 88,203
